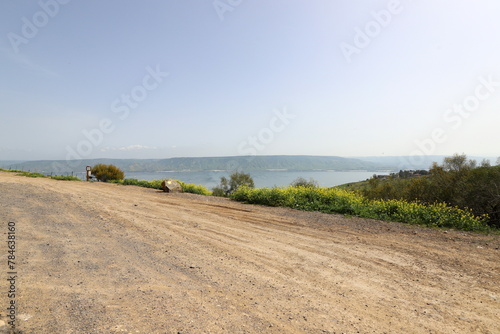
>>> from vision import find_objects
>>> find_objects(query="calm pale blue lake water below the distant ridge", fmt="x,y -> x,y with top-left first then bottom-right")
116,171 -> 387,189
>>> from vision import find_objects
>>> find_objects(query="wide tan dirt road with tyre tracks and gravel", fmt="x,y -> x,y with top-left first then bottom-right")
0,172 -> 500,334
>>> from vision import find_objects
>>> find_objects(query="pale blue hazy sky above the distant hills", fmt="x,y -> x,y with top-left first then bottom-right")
0,0 -> 500,160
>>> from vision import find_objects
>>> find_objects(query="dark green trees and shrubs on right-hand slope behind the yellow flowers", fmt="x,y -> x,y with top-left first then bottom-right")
350,155 -> 500,229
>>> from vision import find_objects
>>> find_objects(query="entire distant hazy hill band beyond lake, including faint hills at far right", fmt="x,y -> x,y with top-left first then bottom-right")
0,155 -> 496,174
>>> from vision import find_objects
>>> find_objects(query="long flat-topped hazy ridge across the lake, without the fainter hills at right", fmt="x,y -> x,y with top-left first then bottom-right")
0,155 -> 394,173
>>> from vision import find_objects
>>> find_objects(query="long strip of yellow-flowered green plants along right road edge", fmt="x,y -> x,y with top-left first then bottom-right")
231,187 -> 489,231
